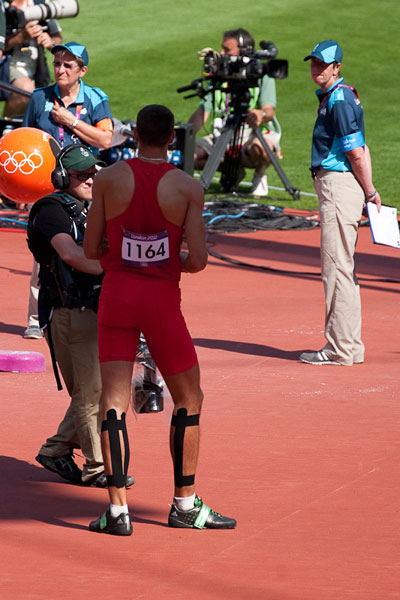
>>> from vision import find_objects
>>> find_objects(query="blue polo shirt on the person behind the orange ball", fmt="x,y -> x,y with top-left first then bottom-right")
22,80 -> 112,146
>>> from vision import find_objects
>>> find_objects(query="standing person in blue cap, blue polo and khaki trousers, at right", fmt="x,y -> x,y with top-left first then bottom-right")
300,40 -> 381,366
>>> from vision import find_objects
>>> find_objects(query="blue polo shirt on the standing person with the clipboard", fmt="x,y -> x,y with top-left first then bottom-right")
311,77 -> 365,171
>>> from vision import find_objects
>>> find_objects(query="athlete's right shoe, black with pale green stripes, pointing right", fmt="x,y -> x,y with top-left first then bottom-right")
168,496 -> 236,529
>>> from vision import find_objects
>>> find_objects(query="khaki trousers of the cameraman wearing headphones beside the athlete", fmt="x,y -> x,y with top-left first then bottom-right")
40,308 -> 104,481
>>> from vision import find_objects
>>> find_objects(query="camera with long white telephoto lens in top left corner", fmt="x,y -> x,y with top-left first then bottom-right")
5,0 -> 79,36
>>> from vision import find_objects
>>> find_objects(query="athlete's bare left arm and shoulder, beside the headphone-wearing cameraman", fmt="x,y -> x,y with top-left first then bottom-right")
83,161 -> 134,258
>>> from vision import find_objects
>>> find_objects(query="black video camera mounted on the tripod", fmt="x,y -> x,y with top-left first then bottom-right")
177,41 -> 289,99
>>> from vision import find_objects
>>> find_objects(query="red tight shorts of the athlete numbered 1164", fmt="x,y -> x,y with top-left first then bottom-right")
98,271 -> 197,376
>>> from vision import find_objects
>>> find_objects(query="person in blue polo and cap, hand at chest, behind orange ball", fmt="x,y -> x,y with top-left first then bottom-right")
22,42 -> 113,152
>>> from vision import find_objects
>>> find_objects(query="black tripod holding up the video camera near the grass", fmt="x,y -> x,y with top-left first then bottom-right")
200,90 -> 300,200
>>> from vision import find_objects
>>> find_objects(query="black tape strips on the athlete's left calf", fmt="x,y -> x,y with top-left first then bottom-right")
101,408 -> 129,488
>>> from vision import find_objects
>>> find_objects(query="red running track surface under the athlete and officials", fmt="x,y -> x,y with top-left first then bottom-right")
0,223 -> 400,600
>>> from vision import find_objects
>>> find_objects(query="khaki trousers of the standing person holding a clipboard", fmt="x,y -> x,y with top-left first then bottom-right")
314,169 -> 364,365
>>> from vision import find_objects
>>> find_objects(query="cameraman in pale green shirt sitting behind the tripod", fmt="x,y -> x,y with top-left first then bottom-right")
189,29 -> 280,197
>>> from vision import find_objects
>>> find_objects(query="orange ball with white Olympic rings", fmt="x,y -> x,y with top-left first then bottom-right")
0,127 -> 60,204
